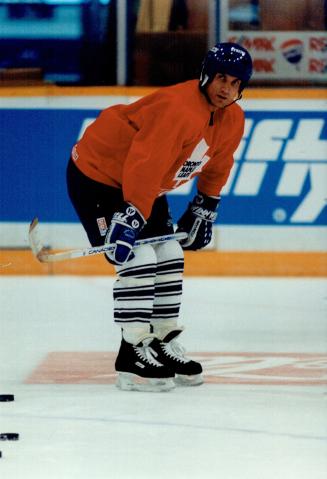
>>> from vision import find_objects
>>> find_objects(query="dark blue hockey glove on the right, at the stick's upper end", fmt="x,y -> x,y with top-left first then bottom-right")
177,192 -> 220,251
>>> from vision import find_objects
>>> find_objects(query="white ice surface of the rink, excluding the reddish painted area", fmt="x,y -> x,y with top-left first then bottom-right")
0,276 -> 327,479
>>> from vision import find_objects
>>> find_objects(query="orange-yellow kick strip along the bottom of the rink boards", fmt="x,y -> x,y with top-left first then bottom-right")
0,249 -> 327,277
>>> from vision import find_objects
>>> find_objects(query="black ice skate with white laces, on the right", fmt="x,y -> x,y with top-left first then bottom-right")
151,328 -> 203,386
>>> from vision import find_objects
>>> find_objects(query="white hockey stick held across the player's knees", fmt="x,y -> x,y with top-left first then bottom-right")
28,218 -> 187,263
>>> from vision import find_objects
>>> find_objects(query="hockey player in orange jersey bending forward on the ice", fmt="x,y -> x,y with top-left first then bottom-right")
67,43 -> 252,390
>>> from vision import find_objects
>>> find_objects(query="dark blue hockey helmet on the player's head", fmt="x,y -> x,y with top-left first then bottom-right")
200,43 -> 253,92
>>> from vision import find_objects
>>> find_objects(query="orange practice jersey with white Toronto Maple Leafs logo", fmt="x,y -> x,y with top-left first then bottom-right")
72,80 -> 244,218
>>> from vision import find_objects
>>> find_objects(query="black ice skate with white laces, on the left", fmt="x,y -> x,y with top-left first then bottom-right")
115,334 -> 175,392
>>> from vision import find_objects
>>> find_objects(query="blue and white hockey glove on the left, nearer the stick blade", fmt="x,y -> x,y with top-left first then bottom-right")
106,203 -> 146,265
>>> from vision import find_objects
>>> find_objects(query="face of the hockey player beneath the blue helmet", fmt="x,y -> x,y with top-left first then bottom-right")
207,73 -> 241,108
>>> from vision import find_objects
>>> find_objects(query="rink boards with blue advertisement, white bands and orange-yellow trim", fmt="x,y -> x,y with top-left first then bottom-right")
0,85 -> 327,276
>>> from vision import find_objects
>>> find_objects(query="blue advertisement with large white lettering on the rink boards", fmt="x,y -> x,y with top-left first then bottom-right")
0,103 -> 327,226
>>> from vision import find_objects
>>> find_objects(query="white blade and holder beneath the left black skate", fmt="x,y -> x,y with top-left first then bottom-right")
116,373 -> 175,392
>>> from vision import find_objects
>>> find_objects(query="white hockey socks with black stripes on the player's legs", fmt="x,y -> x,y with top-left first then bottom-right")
113,241 -> 184,326
